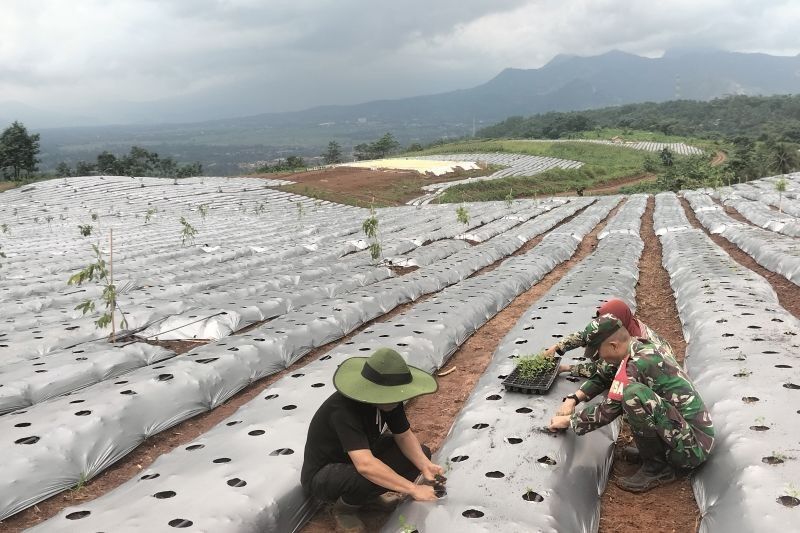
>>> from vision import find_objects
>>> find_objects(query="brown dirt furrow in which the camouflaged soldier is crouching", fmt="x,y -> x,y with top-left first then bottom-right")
600,197 -> 700,533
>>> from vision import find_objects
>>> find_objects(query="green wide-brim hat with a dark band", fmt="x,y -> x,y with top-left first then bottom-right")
333,348 -> 439,404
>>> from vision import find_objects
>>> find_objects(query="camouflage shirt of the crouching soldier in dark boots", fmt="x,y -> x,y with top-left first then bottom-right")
570,339 -> 714,449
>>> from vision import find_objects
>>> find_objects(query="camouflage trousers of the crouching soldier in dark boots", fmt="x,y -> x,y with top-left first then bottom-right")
622,383 -> 708,468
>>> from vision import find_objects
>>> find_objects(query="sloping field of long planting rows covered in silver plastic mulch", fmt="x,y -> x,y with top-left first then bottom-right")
0,175 -> 800,532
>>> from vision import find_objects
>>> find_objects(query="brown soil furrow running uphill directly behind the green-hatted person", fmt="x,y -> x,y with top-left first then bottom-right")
300,198 -> 621,533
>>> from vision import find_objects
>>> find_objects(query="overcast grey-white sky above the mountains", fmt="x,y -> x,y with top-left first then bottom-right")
0,0 -> 800,122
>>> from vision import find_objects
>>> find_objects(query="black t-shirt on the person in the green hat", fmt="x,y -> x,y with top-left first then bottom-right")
300,391 -> 411,485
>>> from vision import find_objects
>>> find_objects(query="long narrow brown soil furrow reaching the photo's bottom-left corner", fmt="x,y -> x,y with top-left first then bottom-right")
0,202 -> 572,533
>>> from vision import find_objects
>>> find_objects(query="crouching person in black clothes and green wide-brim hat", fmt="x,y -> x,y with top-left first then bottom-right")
300,348 -> 444,533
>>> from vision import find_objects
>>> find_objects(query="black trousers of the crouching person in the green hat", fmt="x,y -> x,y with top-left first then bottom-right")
309,435 -> 431,505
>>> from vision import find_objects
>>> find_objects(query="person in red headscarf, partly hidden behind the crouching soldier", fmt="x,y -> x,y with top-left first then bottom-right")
545,298 -> 672,378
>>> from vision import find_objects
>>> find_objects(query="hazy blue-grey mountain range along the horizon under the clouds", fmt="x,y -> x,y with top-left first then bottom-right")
17,49 -> 800,174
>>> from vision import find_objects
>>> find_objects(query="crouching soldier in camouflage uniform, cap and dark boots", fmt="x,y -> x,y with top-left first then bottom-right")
550,315 -> 714,492
